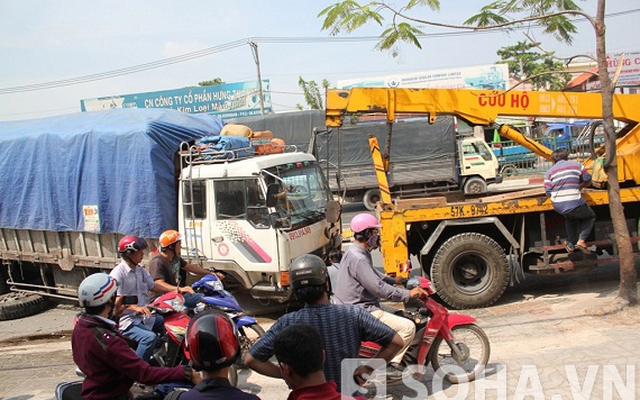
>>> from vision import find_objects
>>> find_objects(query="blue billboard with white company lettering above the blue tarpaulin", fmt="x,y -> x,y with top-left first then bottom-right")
80,79 -> 272,119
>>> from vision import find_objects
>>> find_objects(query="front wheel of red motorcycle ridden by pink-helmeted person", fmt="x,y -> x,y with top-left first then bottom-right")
430,324 -> 491,383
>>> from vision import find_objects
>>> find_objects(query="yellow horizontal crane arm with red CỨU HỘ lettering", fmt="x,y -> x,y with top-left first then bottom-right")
326,88 -> 640,127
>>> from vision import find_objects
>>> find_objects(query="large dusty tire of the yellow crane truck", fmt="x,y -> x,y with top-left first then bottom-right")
431,232 -> 509,309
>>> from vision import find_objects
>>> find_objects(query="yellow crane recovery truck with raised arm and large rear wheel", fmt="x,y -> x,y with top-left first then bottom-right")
326,88 -> 640,308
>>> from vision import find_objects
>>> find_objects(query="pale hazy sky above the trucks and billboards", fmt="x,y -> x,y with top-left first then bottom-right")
0,0 -> 640,121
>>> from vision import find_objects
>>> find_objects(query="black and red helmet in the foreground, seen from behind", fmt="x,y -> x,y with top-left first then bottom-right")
186,310 -> 240,371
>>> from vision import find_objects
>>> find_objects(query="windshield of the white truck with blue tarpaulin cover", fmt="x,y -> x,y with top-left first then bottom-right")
278,162 -> 330,227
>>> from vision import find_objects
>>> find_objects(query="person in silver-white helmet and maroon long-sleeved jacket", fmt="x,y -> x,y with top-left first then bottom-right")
71,273 -> 200,400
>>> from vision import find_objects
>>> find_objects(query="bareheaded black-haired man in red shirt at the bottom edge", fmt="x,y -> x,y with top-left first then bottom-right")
273,325 -> 365,400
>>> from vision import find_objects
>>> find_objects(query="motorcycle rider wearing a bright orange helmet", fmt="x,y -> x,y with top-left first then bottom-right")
149,229 -> 224,308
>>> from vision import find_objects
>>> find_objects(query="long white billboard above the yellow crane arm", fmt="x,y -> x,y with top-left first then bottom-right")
338,64 -> 509,90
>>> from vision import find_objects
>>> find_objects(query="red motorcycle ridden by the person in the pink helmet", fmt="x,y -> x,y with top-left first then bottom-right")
360,277 -> 491,383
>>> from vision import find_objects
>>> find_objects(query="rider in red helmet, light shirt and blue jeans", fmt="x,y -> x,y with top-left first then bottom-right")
109,236 -> 168,362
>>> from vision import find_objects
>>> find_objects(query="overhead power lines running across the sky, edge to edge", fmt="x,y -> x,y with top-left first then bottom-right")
0,9 -> 640,94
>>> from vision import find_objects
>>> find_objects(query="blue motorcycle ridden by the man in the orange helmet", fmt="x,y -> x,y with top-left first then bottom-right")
191,275 -> 264,386
